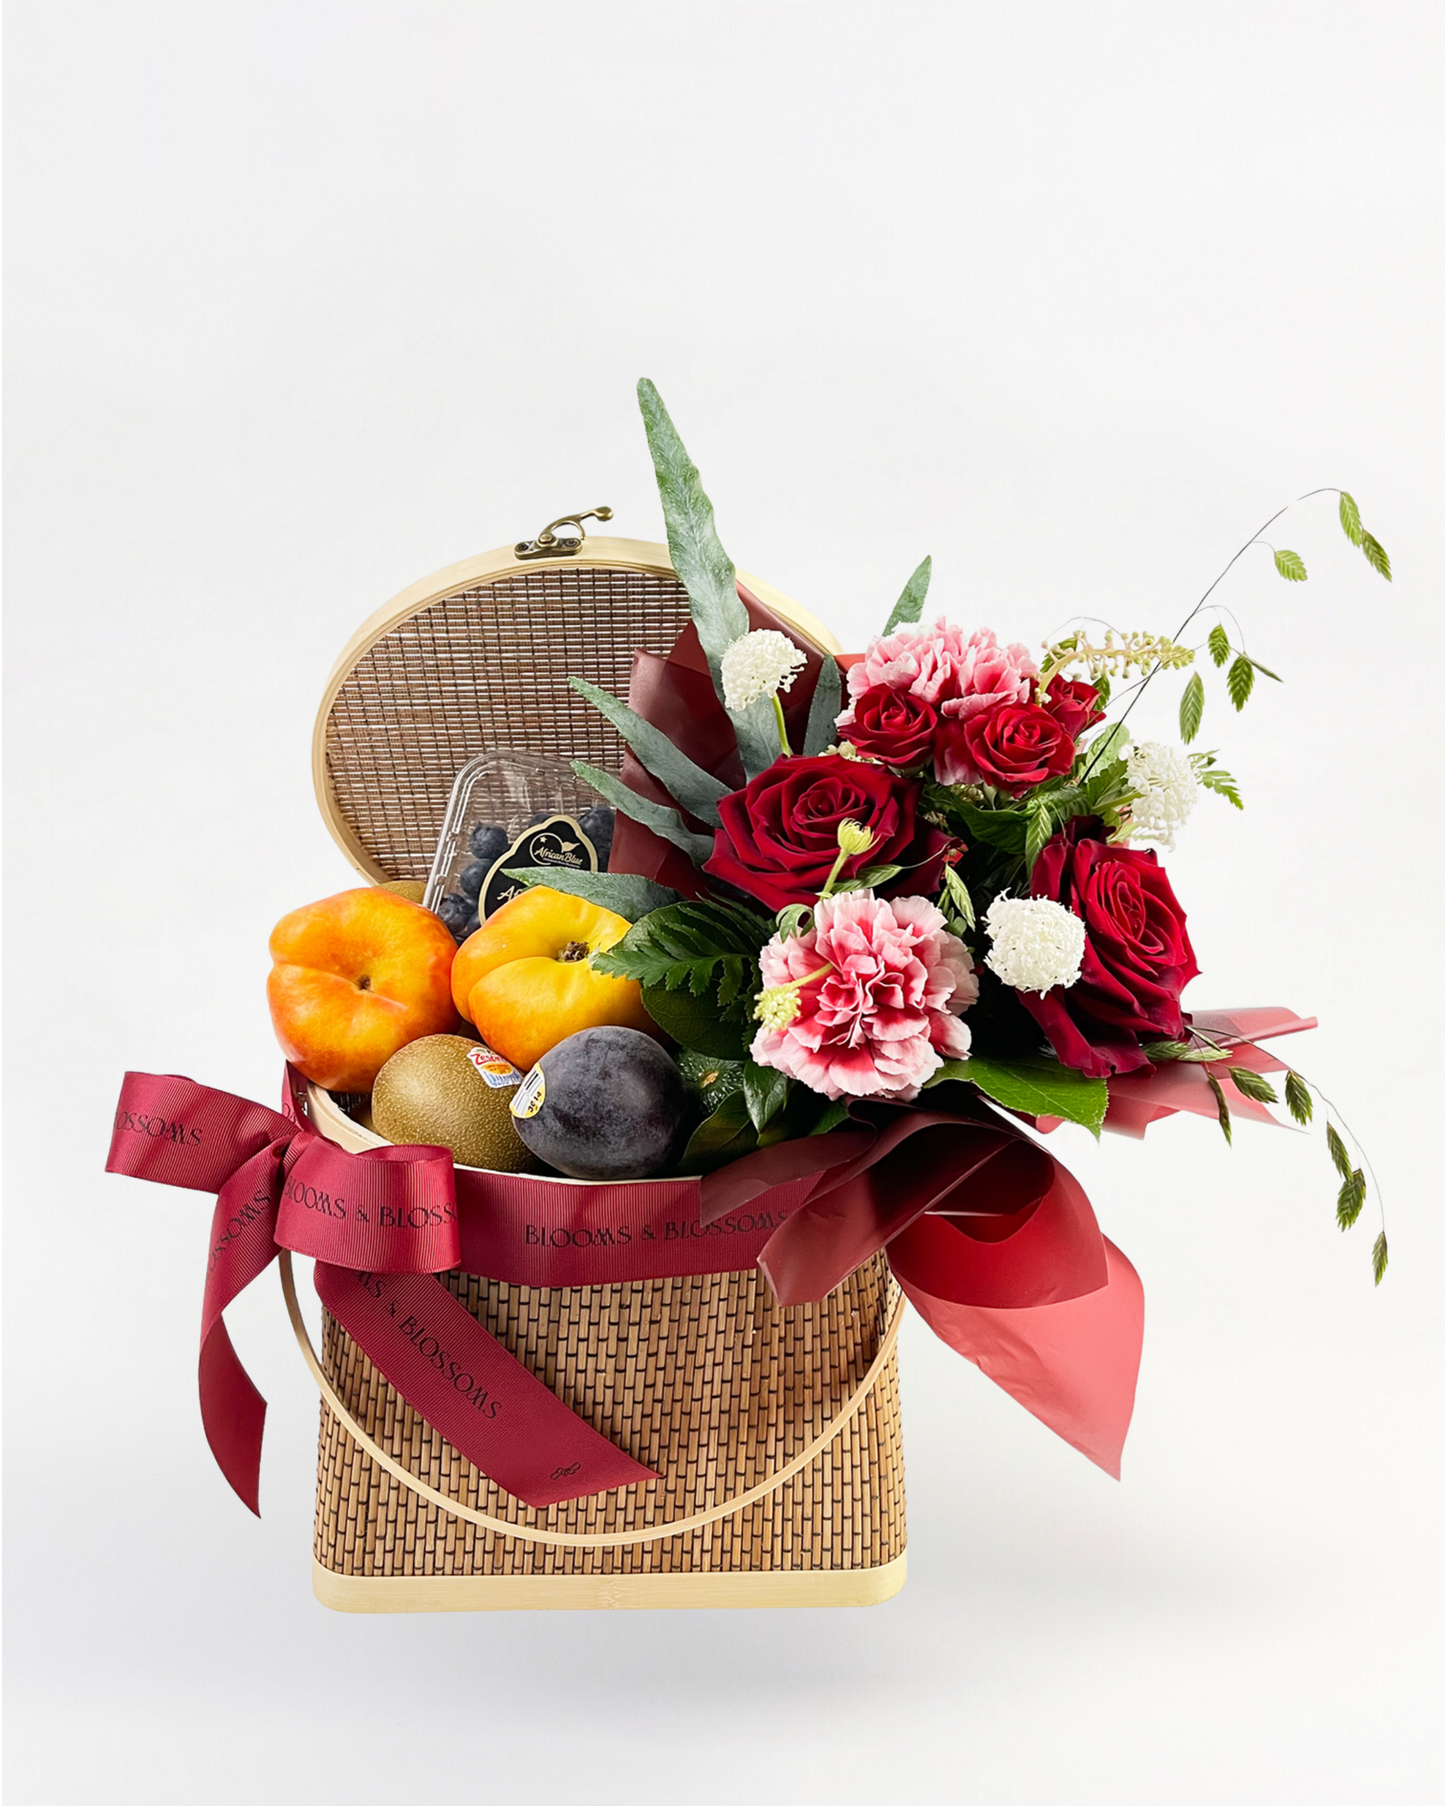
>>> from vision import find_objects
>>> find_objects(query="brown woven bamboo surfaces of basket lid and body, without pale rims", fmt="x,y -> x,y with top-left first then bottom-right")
314,547 -> 907,1577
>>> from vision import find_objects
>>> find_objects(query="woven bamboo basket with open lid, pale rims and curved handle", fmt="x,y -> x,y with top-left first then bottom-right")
305,538 -> 907,1611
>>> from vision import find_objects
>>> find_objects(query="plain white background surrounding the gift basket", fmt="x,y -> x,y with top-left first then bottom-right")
7,0 -> 1445,1806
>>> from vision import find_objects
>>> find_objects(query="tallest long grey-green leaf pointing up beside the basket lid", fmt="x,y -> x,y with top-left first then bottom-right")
638,377 -> 778,777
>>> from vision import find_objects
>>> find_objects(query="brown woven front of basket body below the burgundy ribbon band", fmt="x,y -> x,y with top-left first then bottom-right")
314,1259 -> 905,1577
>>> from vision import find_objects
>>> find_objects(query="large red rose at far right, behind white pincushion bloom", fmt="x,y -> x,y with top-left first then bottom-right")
1017,816 -> 1199,1078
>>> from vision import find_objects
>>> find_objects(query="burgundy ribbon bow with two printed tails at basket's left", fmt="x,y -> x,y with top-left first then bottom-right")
105,1071 -> 656,1512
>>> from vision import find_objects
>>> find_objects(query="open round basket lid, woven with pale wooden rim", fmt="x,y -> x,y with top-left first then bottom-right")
311,538 -> 840,881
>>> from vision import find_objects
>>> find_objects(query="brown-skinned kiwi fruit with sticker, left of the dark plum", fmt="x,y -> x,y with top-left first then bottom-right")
372,1035 -> 538,1172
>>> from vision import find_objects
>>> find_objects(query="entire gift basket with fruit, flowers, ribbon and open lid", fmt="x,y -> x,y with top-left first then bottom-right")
108,383 -> 1389,1611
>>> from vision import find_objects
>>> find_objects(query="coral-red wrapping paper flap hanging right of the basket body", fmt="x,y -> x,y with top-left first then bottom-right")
890,1232 -> 1143,1479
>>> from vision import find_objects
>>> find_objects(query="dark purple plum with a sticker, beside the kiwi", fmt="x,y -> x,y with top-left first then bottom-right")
513,1028 -> 686,1179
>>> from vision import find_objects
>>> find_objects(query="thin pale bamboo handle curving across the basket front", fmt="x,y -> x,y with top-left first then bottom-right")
278,1248 -> 905,1550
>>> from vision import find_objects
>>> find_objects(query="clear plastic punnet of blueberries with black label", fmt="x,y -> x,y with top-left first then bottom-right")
423,748 -> 614,941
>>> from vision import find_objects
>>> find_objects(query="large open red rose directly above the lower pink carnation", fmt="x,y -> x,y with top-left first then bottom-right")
703,753 -> 946,910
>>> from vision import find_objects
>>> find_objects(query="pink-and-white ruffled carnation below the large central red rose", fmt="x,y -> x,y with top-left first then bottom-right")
751,890 -> 979,1102
